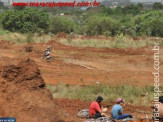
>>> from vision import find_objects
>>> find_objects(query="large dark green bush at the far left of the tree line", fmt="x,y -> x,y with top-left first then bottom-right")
2,8 -> 49,33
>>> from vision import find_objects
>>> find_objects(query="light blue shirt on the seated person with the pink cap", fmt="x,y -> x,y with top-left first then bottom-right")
111,104 -> 122,119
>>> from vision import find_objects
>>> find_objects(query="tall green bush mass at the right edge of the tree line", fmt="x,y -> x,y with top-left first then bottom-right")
120,11 -> 163,37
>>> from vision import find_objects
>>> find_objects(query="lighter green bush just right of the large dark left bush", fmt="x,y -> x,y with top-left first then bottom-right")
49,17 -> 75,34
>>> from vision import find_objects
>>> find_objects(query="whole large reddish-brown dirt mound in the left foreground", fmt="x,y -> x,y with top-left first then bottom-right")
0,59 -> 66,122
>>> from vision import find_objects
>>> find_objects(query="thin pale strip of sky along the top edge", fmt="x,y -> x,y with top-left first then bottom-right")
0,0 -> 161,3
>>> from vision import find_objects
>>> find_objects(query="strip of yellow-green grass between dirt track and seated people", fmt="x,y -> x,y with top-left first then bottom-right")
47,83 -> 163,106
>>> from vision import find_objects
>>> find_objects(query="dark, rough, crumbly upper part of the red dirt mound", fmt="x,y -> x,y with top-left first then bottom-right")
1,59 -> 45,89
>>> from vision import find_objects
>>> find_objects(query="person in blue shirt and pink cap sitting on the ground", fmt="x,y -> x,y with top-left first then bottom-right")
111,98 -> 133,120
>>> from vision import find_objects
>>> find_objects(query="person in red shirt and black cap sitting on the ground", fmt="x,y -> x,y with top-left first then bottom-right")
89,96 -> 108,119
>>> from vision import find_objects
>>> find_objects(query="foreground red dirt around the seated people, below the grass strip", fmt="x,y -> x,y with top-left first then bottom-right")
54,99 -> 152,122
